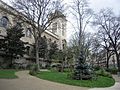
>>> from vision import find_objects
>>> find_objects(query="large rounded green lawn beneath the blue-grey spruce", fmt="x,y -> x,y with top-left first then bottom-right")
36,71 -> 115,88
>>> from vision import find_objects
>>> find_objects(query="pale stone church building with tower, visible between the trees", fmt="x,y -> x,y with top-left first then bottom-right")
0,0 -> 67,67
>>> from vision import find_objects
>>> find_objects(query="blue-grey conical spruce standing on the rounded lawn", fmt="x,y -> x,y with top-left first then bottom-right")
73,50 -> 92,80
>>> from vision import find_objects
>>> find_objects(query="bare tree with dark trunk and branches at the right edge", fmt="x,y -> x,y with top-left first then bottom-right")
94,9 -> 120,72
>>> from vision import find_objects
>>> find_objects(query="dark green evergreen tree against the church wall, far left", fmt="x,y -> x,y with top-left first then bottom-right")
5,23 -> 25,67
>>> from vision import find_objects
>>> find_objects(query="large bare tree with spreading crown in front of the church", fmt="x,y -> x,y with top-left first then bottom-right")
13,0 -> 64,69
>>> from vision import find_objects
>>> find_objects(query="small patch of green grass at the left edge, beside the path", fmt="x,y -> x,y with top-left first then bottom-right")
0,70 -> 17,79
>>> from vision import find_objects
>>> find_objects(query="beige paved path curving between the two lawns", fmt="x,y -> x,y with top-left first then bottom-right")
0,71 -> 88,90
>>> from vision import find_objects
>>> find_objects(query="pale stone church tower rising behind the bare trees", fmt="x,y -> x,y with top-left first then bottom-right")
51,10 -> 67,50
